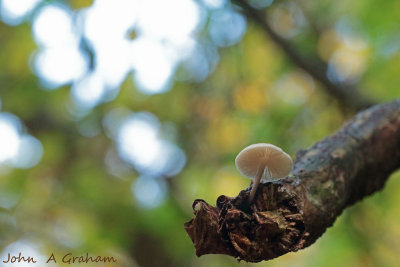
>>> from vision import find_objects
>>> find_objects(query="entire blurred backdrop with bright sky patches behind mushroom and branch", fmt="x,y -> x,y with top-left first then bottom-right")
0,0 -> 400,267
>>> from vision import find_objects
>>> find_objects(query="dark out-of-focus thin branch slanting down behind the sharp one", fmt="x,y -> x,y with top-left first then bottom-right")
233,0 -> 374,111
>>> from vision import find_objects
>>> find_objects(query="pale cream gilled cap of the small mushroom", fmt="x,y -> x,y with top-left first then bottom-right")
235,143 -> 293,181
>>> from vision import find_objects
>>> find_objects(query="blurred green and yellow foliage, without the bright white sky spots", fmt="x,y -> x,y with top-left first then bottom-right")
0,0 -> 400,267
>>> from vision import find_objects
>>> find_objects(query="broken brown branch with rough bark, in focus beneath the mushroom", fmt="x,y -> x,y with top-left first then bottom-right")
184,99 -> 400,262
